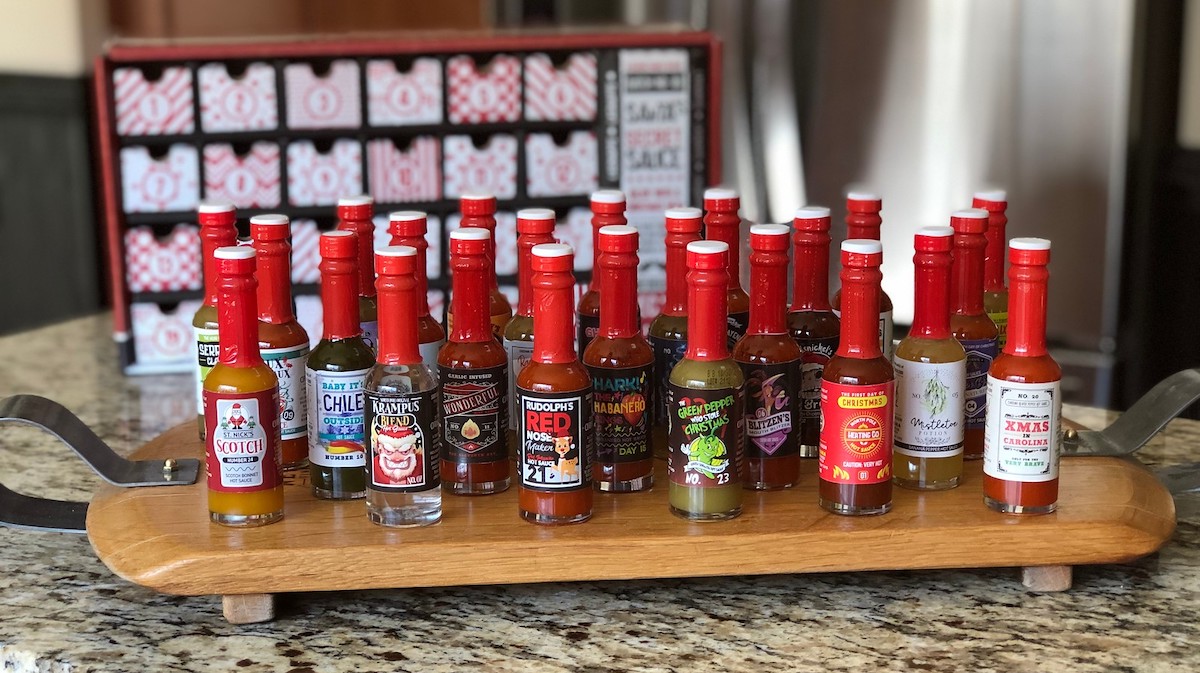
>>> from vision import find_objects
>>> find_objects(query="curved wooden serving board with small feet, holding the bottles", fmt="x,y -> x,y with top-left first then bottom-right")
88,423 -> 1175,621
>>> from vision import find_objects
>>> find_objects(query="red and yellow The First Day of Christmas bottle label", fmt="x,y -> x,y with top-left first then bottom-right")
817,380 -> 895,485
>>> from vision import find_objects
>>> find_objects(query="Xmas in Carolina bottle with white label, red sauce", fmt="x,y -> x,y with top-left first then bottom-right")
983,239 -> 1062,515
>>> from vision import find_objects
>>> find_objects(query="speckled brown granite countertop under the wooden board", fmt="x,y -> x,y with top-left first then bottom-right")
0,314 -> 1200,672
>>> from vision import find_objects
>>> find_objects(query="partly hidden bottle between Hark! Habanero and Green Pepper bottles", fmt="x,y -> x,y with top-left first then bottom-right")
649,208 -> 704,459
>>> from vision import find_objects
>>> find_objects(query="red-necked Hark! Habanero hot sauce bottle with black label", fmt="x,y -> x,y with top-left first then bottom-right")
583,226 -> 654,492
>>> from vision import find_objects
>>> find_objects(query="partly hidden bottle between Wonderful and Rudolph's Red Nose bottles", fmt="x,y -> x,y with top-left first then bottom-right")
504,208 -> 556,458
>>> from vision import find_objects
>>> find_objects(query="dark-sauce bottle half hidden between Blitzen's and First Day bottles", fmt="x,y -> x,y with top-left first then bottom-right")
787,206 -> 841,458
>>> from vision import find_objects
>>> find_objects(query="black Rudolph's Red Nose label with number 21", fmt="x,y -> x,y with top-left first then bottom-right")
517,387 -> 594,492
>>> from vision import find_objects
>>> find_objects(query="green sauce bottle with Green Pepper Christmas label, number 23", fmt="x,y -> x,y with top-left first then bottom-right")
667,241 -> 745,521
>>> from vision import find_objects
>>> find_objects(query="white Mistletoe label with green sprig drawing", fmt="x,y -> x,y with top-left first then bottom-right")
894,357 -> 967,458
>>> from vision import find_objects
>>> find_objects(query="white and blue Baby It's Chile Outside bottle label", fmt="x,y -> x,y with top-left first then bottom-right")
305,369 -> 368,468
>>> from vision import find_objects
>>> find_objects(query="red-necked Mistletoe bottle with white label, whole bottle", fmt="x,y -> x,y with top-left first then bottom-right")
893,227 -> 967,491
